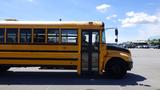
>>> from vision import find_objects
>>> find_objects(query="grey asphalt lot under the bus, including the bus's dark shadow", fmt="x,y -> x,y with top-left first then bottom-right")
0,49 -> 160,90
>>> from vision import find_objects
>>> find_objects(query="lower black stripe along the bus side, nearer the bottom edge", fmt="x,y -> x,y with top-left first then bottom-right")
0,57 -> 78,60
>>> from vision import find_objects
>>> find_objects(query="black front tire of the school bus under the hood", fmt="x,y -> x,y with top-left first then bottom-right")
105,58 -> 127,79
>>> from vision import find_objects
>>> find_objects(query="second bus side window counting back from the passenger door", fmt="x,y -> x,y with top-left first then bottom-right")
47,29 -> 59,43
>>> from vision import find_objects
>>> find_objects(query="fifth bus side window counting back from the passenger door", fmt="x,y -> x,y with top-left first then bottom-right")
6,28 -> 18,43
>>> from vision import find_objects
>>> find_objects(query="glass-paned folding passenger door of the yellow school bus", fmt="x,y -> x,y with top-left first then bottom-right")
81,30 -> 100,74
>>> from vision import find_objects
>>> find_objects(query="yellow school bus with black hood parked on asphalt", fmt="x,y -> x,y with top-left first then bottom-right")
0,21 -> 132,78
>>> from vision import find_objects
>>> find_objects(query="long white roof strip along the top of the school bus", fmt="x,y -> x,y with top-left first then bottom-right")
0,21 -> 103,26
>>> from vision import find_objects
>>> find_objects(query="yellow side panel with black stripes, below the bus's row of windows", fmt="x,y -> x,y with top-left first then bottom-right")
0,45 -> 78,65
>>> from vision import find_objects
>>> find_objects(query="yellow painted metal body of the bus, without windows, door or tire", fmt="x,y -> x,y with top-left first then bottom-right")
0,22 -> 131,74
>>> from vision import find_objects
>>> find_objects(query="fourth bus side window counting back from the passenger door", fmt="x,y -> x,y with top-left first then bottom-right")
20,28 -> 32,43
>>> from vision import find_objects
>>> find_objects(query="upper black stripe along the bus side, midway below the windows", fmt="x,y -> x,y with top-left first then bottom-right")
0,50 -> 78,53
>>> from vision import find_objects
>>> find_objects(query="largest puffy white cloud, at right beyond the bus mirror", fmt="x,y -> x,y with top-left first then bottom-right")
119,11 -> 159,27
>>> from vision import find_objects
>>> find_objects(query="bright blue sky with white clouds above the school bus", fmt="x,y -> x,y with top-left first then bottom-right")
0,0 -> 160,42
